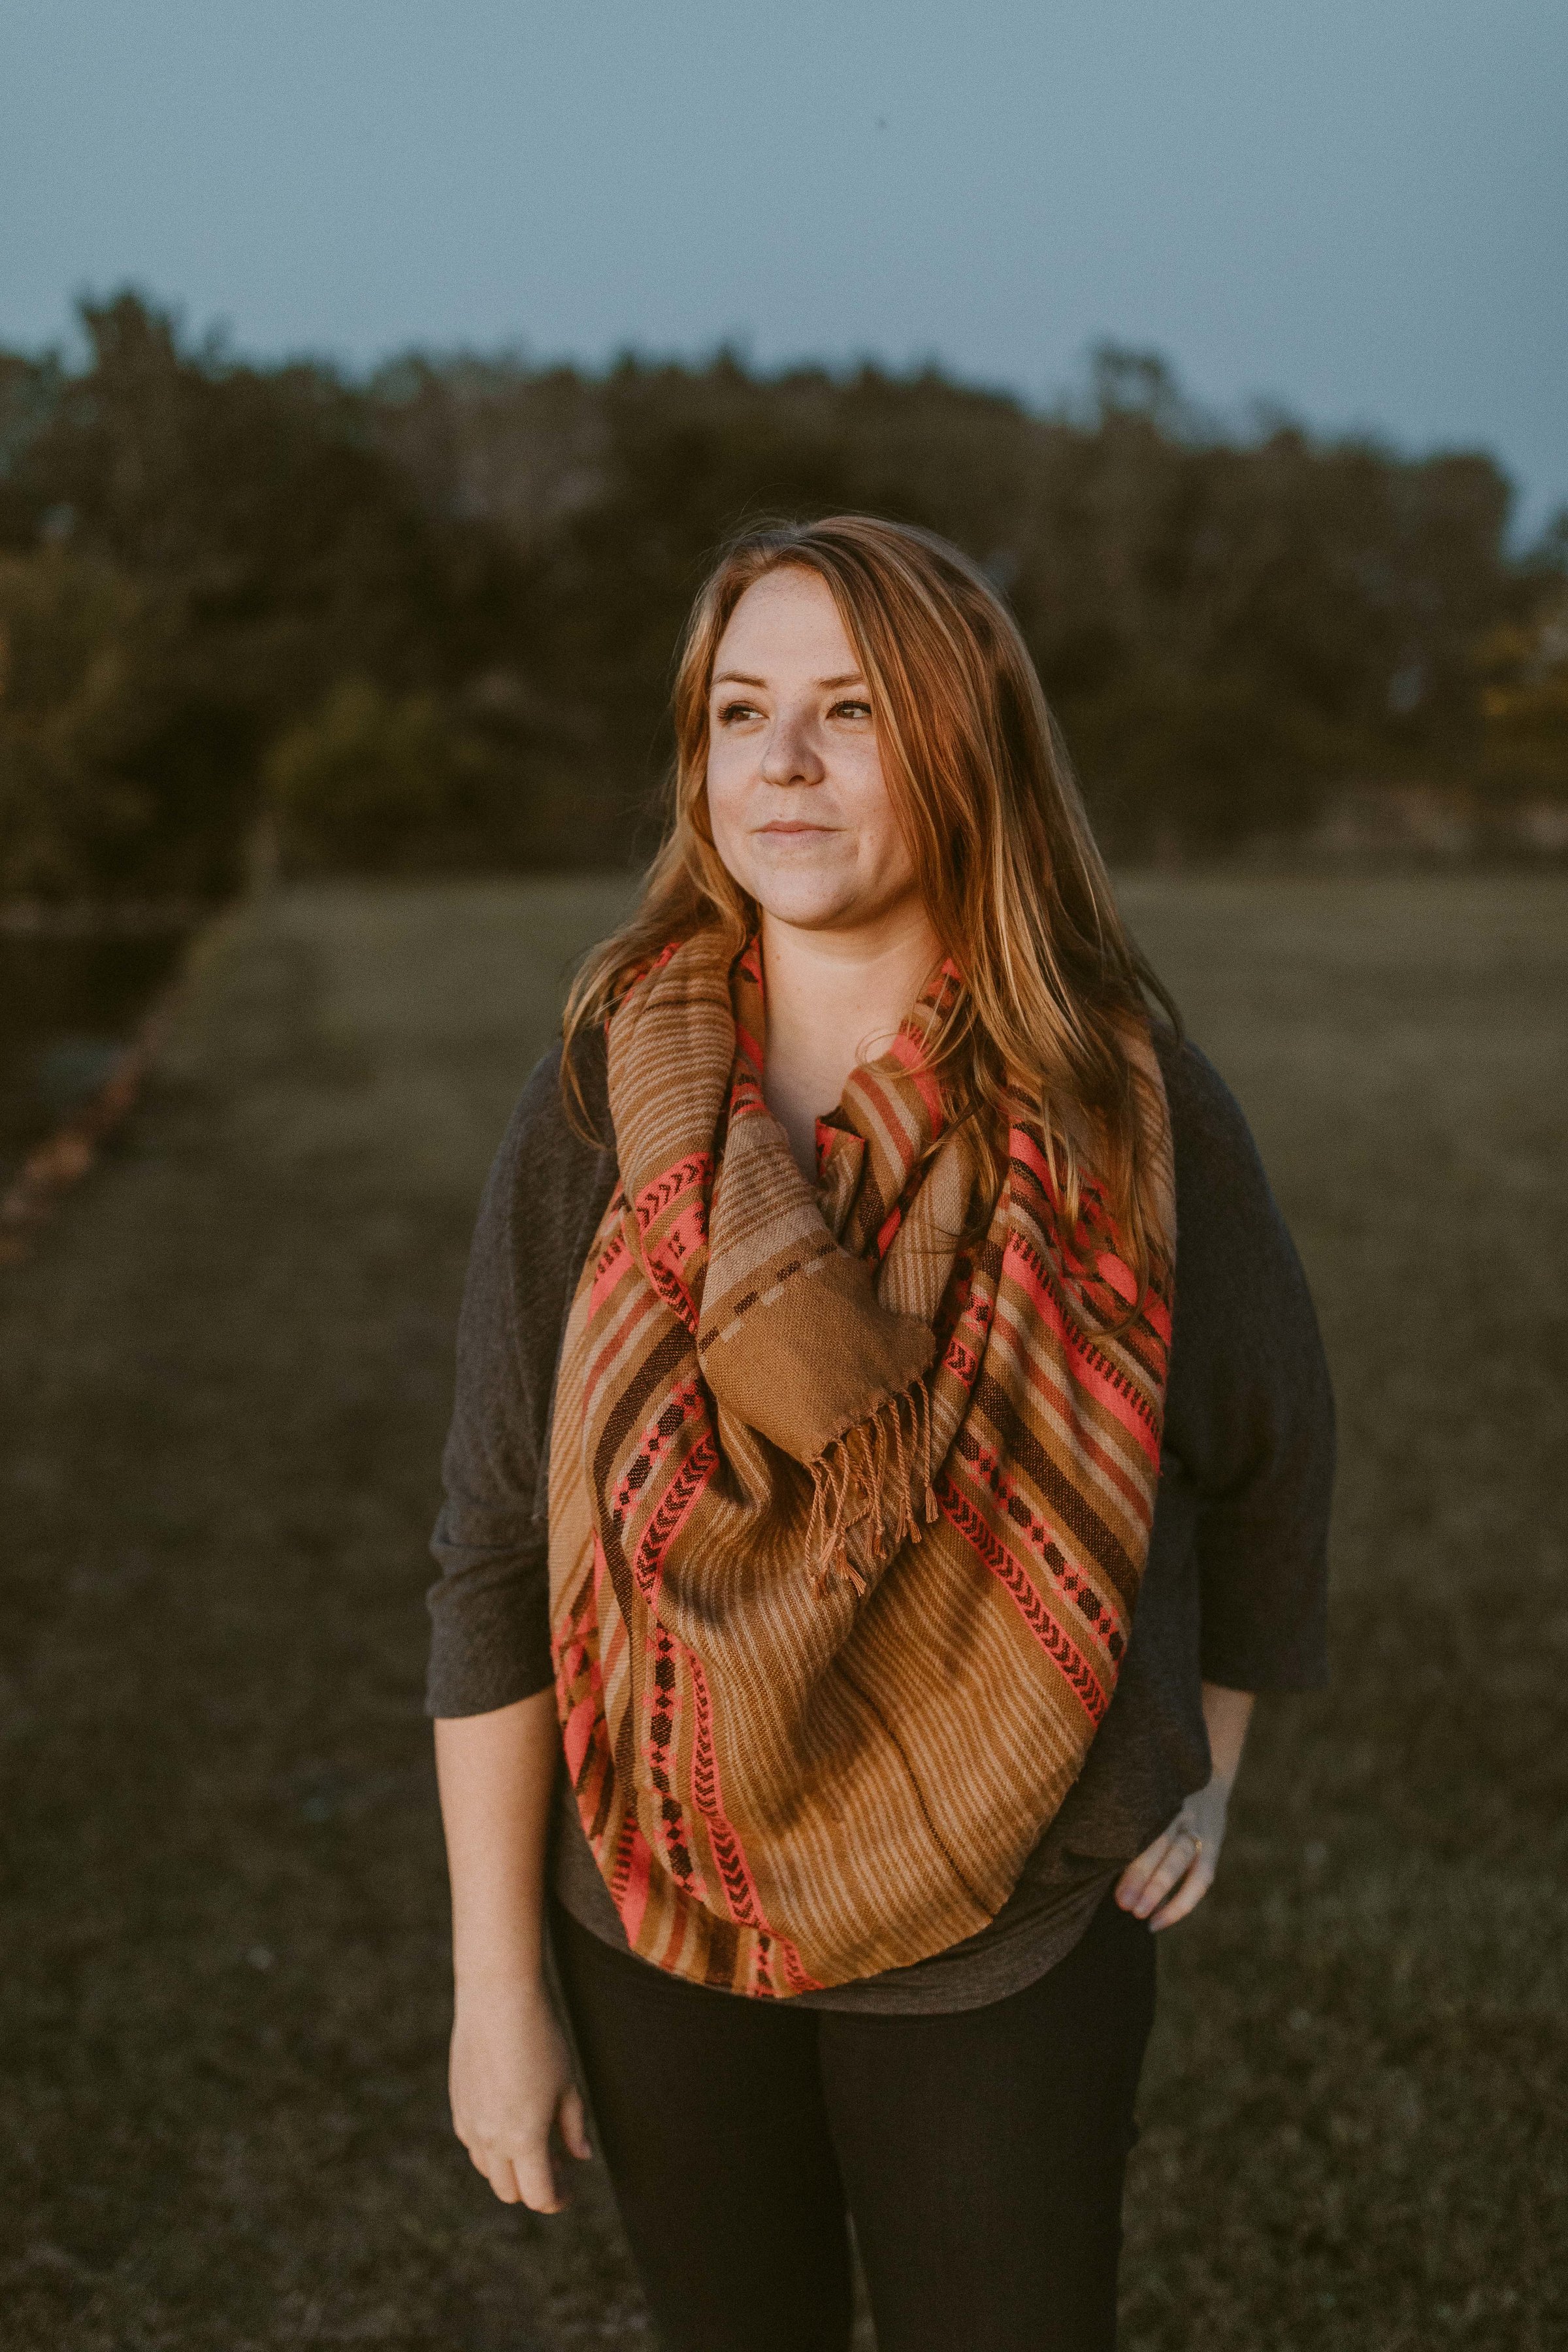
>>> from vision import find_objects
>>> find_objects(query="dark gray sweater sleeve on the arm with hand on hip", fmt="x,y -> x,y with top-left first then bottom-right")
1166,1044 -> 1333,1691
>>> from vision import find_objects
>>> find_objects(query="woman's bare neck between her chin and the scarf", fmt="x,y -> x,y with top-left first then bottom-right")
762,901 -> 943,1176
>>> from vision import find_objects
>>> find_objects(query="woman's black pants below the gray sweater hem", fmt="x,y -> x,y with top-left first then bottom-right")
555,1896 -> 1154,2352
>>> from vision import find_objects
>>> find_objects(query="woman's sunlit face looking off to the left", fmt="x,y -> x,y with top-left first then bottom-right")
708,567 -> 917,932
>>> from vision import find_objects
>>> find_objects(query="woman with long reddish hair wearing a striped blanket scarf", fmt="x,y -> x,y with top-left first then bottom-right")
430,515 -> 1331,2352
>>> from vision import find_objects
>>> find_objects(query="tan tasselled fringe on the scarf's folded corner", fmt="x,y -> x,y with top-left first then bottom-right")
806,1376 -> 938,1599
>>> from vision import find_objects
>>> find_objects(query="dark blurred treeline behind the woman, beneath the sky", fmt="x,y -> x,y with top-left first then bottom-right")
0,294 -> 1568,898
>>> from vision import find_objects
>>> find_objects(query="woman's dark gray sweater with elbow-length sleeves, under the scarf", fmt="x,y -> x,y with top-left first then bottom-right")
428,1039 -> 1333,2014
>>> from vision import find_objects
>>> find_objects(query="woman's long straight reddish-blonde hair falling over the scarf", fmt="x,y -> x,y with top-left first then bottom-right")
562,515 -> 1180,1286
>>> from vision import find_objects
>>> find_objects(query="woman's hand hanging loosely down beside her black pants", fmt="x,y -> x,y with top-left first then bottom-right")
449,1983 -> 593,2213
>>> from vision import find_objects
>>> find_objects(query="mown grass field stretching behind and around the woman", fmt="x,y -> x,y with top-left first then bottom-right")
0,879 -> 1568,2352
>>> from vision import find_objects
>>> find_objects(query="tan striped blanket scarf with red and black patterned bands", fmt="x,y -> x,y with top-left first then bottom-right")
550,936 -> 1173,1997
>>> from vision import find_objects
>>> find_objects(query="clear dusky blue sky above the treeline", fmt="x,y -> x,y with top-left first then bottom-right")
0,0 -> 1568,525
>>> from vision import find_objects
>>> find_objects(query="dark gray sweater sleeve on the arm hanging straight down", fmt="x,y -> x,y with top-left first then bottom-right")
425,1049 -> 613,1714
